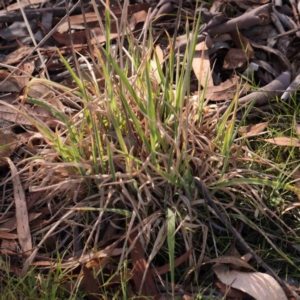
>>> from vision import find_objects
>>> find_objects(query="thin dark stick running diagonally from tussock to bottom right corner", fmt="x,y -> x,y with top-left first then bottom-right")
194,177 -> 300,300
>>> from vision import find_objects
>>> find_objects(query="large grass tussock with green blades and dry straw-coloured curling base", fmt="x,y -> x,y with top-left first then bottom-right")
1,3 -> 299,299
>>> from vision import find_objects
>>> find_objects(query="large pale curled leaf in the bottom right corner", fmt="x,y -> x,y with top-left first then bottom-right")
213,264 -> 287,300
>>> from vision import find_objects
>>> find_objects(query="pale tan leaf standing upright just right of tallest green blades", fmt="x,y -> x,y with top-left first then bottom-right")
192,41 -> 214,87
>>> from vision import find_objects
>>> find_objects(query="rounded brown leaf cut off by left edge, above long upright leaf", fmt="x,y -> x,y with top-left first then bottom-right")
0,127 -> 17,166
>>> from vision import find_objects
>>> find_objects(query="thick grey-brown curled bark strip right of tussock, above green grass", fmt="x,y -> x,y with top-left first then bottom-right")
219,71 -> 291,114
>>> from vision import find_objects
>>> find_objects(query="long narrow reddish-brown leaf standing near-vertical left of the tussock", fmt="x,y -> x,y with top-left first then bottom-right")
7,158 -> 32,254
